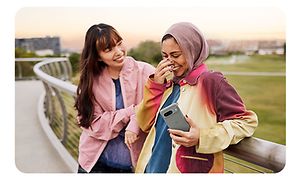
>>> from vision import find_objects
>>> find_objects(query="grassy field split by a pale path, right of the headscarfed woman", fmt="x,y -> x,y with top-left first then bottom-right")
207,55 -> 286,144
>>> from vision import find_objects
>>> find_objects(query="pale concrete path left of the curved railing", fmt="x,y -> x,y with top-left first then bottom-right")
15,81 -> 71,173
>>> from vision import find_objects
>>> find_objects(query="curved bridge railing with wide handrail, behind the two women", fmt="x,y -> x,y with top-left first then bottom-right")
34,58 -> 286,173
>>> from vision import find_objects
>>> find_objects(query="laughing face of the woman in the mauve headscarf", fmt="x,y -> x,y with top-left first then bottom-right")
161,37 -> 189,77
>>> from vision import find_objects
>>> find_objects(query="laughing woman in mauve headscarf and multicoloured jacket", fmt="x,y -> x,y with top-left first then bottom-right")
136,22 -> 258,173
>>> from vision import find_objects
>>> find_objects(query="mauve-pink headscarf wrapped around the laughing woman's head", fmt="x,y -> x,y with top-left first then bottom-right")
164,22 -> 209,76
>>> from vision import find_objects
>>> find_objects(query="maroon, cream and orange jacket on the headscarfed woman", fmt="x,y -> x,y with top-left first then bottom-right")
136,64 -> 258,173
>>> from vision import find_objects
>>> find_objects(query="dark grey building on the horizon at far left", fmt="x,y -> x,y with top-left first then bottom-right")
15,37 -> 61,56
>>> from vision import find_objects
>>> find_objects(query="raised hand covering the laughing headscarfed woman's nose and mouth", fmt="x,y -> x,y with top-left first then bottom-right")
153,59 -> 174,84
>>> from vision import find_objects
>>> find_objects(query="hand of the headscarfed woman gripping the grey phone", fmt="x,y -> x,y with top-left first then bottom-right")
168,116 -> 200,147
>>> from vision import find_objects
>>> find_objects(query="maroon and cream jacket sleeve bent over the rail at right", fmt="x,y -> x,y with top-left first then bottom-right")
196,77 -> 258,153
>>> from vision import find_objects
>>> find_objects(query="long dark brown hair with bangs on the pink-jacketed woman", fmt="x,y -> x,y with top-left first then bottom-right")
74,23 -> 122,128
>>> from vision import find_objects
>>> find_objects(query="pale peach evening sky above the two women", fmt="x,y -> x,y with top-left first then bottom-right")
15,6 -> 286,50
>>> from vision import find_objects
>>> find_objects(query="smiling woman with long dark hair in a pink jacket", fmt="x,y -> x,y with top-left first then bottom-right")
75,24 -> 154,173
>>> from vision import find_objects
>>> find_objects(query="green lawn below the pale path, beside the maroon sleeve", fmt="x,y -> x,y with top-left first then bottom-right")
227,76 -> 286,144
